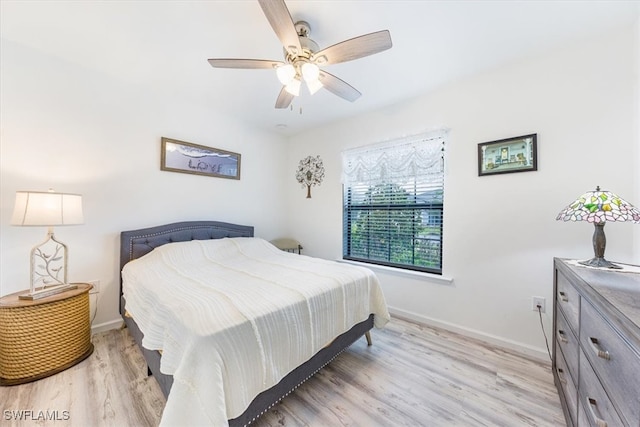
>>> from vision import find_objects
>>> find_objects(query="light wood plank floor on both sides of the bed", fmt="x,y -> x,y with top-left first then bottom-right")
0,318 -> 565,427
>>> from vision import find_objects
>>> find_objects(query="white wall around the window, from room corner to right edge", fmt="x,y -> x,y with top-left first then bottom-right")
287,22 -> 640,357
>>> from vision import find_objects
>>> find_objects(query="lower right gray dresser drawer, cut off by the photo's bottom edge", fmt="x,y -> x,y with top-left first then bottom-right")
578,351 -> 624,427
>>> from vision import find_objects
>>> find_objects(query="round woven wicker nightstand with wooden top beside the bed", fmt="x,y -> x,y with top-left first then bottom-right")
0,283 -> 93,385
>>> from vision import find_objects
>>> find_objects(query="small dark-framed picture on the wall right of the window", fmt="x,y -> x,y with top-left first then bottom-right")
478,133 -> 538,176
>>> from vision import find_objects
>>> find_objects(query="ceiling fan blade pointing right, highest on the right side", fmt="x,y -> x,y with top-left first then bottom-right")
312,30 -> 393,65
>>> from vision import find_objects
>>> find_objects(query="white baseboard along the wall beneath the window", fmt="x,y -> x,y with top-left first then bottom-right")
389,307 -> 551,365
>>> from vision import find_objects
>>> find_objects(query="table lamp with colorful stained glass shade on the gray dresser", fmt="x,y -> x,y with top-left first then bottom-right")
556,187 -> 640,268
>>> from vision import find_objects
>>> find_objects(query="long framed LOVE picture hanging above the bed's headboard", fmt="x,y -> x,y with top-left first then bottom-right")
160,137 -> 240,179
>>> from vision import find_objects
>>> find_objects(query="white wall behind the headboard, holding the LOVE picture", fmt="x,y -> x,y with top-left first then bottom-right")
0,40 -> 285,327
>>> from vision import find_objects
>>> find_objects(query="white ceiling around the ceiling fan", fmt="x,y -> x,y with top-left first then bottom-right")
0,0 -> 640,135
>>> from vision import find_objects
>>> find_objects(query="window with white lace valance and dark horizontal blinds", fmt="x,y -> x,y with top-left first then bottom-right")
342,132 -> 446,274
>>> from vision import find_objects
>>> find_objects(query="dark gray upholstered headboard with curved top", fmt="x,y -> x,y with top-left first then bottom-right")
120,221 -> 253,313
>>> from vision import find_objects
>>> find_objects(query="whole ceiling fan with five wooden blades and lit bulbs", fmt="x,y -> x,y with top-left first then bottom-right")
208,0 -> 392,108
